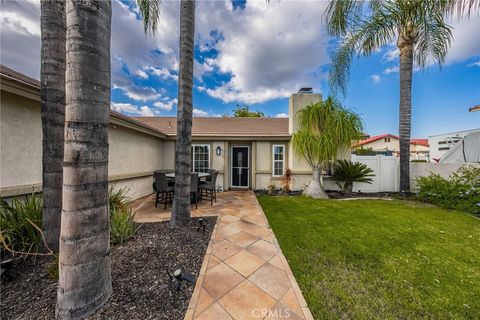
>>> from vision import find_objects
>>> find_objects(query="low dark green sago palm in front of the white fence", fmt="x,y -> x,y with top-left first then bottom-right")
333,160 -> 375,192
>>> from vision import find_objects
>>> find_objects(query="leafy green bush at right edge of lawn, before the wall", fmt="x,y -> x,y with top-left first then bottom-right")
416,166 -> 480,213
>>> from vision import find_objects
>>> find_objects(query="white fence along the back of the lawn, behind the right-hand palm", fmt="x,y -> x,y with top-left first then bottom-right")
352,154 -> 480,192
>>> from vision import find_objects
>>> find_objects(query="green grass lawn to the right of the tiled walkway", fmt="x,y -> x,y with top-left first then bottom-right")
258,196 -> 480,319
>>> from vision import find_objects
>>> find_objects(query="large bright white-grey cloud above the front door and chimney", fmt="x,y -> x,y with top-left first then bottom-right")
196,1 -> 329,103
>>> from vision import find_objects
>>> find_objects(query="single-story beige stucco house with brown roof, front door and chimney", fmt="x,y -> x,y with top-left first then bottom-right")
0,65 -> 335,198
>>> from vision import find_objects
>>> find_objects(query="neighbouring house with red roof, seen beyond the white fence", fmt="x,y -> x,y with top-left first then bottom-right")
352,133 -> 430,160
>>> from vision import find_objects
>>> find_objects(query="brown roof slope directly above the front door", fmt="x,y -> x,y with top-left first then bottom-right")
135,117 -> 290,137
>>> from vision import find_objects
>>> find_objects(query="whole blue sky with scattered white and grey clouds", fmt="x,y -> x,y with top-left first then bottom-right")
0,0 -> 480,137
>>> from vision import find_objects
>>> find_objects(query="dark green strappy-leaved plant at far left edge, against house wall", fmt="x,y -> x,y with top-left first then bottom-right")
0,194 -> 42,253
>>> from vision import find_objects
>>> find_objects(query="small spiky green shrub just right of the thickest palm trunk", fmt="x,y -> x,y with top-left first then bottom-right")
110,208 -> 137,244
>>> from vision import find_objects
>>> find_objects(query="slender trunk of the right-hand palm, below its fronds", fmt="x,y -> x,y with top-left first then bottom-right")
397,37 -> 413,193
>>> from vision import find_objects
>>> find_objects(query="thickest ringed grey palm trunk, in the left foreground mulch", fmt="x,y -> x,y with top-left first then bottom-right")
56,0 -> 112,319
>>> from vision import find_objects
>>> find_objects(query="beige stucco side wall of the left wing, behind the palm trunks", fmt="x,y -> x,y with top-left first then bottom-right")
0,90 -> 163,199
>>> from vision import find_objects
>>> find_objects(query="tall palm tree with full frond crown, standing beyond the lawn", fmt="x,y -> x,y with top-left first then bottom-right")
326,0 -> 480,193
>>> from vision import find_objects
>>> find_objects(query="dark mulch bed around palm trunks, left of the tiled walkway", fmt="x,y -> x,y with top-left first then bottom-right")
0,217 -> 216,320
